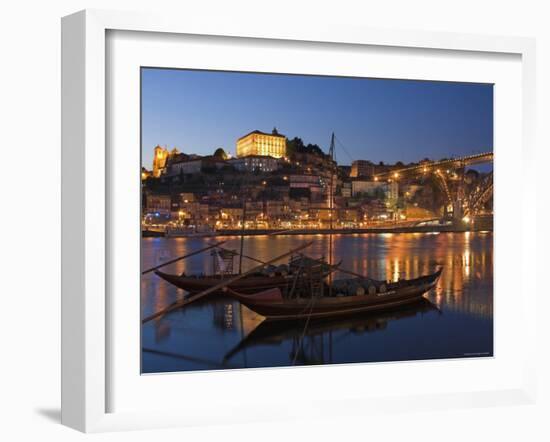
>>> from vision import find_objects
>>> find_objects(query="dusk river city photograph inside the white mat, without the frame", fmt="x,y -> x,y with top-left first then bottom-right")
141,66 -> 494,374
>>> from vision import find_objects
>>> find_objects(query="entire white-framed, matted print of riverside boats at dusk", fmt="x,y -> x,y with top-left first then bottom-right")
62,11 -> 535,431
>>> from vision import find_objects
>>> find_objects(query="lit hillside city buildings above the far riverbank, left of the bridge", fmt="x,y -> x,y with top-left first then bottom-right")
142,129 -> 490,231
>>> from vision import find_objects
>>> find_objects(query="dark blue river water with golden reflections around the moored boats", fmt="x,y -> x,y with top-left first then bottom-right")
141,232 -> 493,373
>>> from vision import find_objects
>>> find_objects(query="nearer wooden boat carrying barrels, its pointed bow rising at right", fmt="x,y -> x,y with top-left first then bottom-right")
226,268 -> 443,321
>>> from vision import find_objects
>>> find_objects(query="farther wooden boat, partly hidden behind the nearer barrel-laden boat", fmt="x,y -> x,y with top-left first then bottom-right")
155,256 -> 338,295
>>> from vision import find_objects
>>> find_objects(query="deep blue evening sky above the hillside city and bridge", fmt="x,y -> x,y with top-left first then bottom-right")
142,68 -> 493,168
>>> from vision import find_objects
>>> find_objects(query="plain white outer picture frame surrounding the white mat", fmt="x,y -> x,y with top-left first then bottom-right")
62,10 -> 536,432
